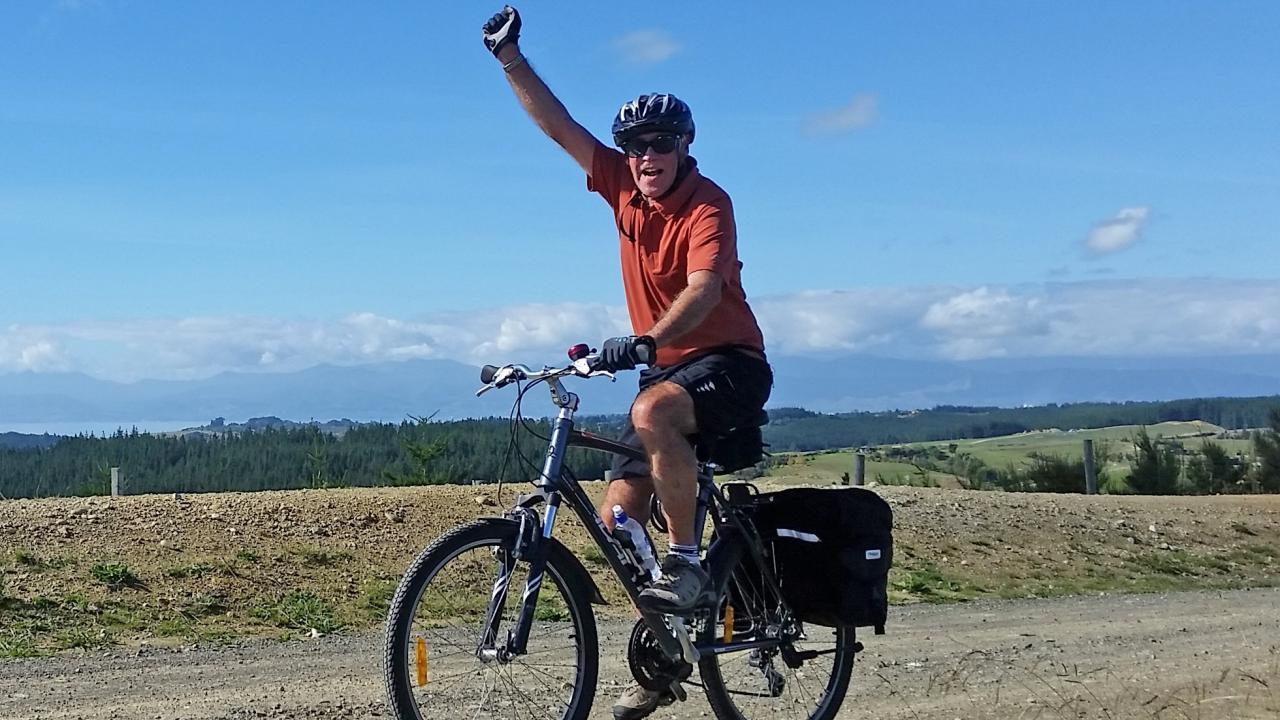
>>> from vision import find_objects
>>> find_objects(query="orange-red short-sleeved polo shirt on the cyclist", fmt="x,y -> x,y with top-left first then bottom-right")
586,145 -> 764,368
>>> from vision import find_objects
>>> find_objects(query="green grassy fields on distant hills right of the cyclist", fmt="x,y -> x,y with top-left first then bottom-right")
769,421 -> 1252,487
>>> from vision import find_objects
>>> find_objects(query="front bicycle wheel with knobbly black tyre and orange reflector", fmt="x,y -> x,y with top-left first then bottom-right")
384,520 -> 599,720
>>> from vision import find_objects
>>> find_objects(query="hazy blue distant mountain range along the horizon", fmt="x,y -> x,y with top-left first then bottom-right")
0,355 -> 1280,429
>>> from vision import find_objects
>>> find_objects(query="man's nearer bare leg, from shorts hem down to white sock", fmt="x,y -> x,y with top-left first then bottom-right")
628,382 -> 698,544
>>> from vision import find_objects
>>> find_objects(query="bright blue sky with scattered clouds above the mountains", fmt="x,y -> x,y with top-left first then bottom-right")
0,0 -> 1280,379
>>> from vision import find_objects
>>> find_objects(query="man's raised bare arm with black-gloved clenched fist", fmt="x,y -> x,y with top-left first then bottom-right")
484,5 -> 600,176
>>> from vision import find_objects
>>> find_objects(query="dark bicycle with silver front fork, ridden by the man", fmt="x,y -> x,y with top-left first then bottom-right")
383,345 -> 863,720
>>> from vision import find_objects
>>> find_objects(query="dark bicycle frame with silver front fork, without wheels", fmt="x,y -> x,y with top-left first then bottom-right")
476,378 -> 782,664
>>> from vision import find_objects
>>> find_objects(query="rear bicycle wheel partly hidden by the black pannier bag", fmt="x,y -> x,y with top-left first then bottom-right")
698,545 -> 856,720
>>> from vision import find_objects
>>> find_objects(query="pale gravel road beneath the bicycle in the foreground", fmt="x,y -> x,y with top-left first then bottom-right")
0,589 -> 1280,720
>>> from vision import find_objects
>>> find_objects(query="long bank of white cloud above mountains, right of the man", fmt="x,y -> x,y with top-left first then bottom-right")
753,278 -> 1280,360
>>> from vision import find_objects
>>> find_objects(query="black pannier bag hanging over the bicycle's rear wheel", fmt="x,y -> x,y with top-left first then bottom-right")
753,488 -> 893,634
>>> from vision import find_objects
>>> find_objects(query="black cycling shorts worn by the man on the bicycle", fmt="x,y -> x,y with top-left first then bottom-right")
612,348 -> 773,479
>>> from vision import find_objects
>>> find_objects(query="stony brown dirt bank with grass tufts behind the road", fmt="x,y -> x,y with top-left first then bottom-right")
0,483 -> 1280,656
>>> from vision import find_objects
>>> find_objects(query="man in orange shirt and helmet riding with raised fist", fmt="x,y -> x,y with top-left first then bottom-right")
484,5 -> 773,720
